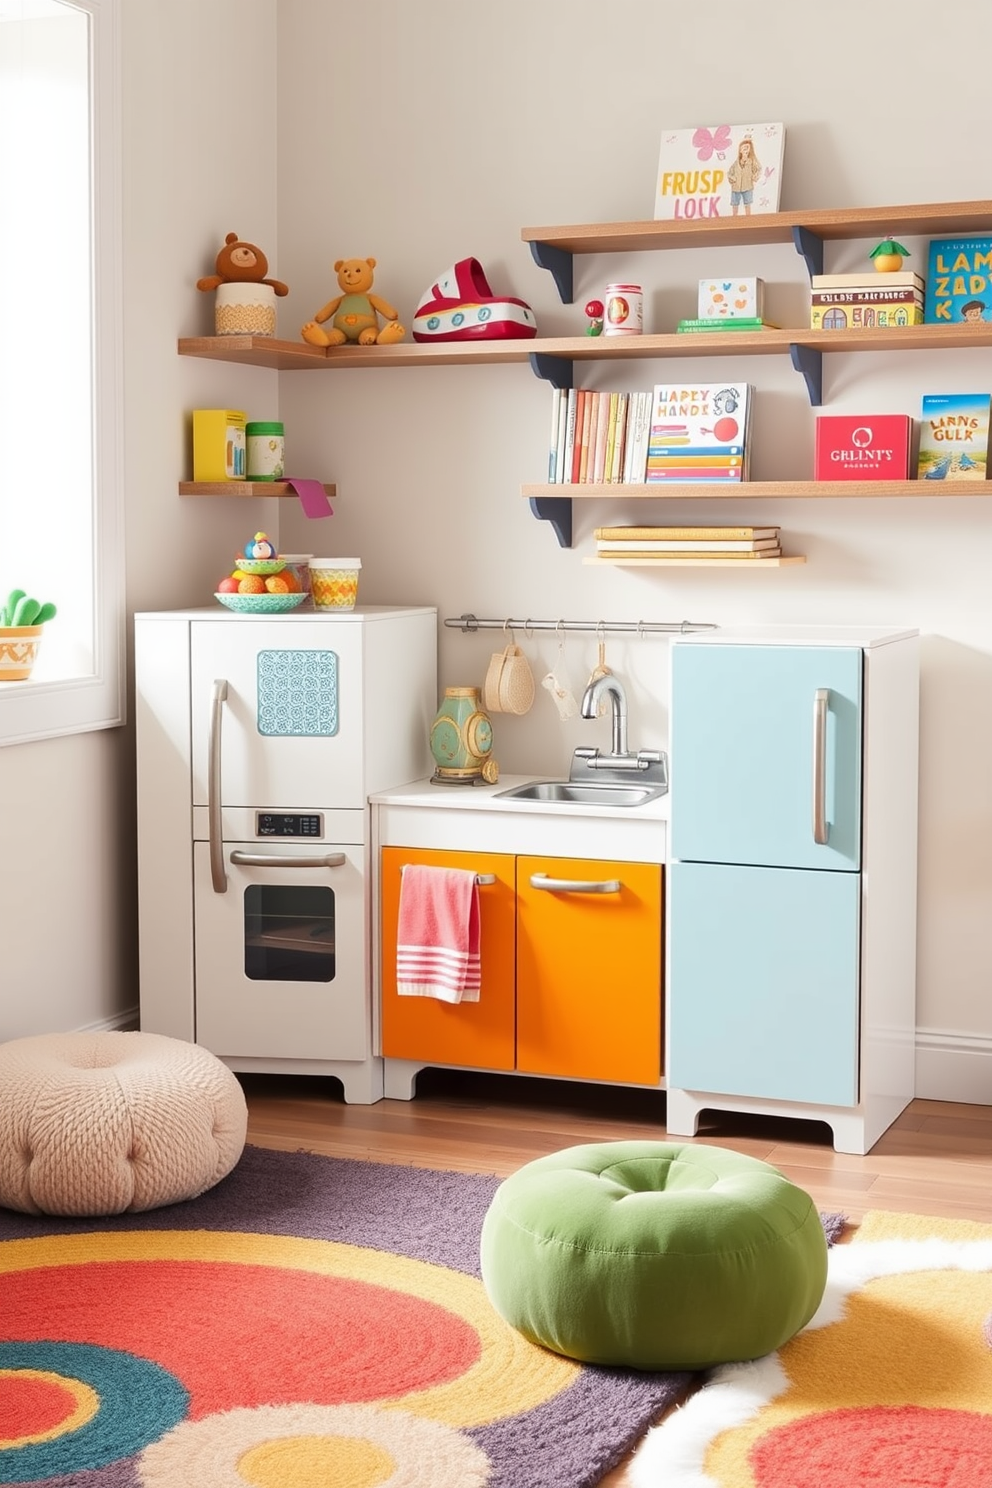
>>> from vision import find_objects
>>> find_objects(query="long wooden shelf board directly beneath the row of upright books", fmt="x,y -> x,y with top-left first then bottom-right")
521,481 -> 992,501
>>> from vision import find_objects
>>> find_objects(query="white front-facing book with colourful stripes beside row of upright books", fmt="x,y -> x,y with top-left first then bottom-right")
645,382 -> 751,485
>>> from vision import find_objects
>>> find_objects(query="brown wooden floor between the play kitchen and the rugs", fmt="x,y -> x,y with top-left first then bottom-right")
239,1070 -> 992,1488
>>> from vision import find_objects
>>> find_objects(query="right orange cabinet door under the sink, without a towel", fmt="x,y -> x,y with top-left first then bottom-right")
516,857 -> 662,1085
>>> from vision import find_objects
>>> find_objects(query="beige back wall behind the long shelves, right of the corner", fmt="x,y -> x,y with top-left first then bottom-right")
278,0 -> 992,1100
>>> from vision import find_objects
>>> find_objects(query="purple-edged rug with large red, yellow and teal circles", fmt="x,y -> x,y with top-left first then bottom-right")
0,1147 -> 689,1488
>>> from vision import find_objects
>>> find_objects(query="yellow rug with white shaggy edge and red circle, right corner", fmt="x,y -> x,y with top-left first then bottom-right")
631,1195 -> 992,1488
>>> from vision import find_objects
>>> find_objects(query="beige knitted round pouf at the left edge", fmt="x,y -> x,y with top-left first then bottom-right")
0,1033 -> 248,1214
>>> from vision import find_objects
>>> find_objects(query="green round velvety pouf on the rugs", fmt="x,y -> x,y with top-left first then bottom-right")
482,1141 -> 827,1369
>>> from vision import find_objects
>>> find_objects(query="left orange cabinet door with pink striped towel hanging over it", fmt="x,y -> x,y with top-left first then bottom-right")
379,847 -> 516,1070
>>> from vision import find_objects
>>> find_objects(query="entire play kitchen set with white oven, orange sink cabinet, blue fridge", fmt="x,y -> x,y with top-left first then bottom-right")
135,609 -> 919,1153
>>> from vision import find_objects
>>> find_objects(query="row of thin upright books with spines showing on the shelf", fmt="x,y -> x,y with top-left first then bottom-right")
547,387 -> 651,485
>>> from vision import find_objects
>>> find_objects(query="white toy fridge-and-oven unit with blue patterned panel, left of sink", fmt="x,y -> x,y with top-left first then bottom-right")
134,606 -> 437,1101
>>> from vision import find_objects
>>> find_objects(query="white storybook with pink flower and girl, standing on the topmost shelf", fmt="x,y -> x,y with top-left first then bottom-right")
654,124 -> 785,220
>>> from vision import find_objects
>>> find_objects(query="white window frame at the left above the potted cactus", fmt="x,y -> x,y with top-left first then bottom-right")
0,0 -> 126,745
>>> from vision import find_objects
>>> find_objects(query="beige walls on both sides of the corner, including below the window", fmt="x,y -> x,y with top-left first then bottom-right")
0,0 -> 992,1100
